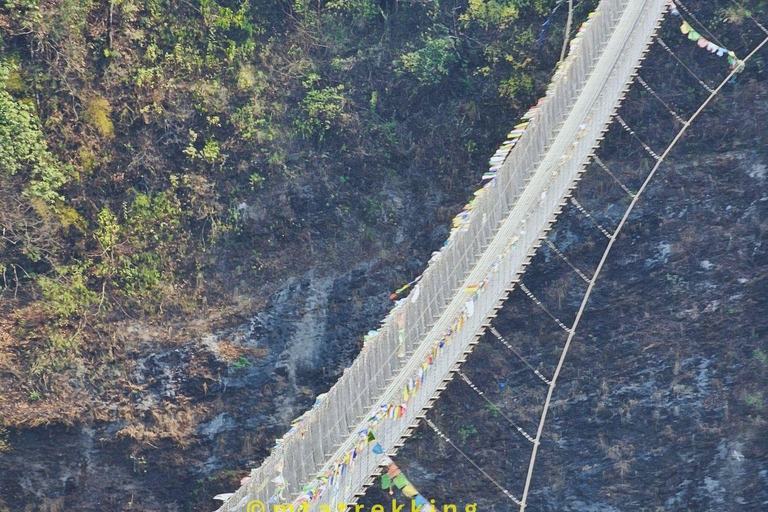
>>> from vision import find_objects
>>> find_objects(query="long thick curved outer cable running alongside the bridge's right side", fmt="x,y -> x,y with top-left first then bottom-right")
520,34 -> 768,512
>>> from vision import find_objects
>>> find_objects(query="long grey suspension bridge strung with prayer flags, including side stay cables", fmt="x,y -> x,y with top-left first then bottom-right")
214,0 -> 768,512
